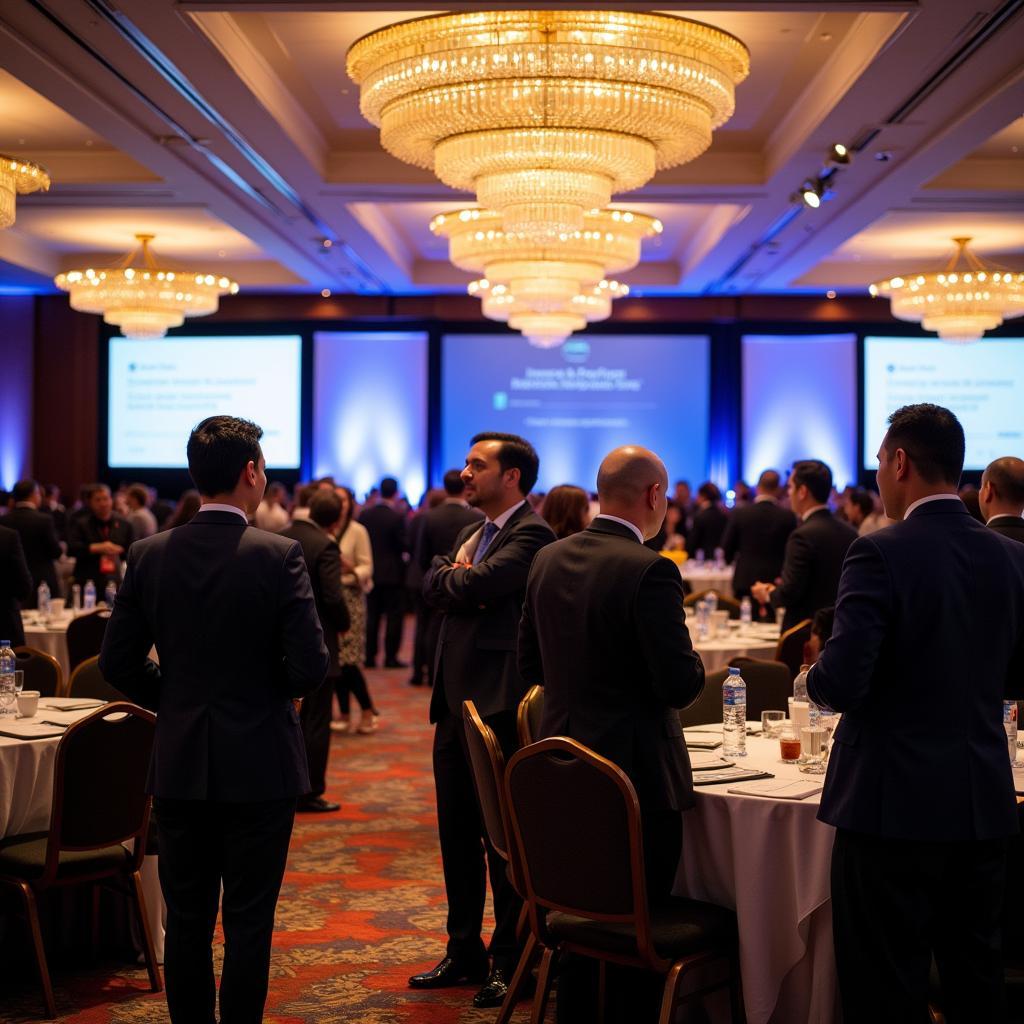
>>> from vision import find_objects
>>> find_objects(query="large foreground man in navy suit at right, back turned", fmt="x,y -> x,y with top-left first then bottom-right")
807,404 -> 1024,1024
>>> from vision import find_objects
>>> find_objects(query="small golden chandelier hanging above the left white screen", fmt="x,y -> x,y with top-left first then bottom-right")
53,234 -> 239,341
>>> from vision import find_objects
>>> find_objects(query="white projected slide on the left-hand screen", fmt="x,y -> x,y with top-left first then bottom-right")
108,335 -> 302,469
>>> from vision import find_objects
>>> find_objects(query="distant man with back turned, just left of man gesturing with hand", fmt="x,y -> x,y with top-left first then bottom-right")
722,469 -> 797,597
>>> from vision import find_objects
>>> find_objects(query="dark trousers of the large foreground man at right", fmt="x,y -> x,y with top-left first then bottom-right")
831,828 -> 1007,1024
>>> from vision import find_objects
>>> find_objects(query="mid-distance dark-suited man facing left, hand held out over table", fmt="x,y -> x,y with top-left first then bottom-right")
751,459 -> 857,631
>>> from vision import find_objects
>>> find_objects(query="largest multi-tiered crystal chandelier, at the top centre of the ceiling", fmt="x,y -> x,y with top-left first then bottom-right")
348,10 -> 750,240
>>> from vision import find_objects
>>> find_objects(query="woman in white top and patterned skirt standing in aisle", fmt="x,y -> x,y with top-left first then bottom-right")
331,487 -> 379,735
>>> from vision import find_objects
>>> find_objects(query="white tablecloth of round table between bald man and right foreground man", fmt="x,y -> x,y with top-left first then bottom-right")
676,723 -> 842,1024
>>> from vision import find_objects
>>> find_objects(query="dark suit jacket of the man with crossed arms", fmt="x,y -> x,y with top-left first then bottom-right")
423,504 -> 555,722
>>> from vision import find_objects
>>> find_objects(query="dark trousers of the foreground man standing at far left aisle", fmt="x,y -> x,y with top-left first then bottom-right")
154,798 -> 295,1024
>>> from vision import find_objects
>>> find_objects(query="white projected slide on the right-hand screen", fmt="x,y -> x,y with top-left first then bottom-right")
863,338 -> 1024,470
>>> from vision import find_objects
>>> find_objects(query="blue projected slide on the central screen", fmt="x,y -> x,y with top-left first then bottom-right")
441,335 -> 709,490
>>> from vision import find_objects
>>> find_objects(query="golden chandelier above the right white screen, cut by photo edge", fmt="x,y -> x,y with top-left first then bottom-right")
868,239 -> 1024,343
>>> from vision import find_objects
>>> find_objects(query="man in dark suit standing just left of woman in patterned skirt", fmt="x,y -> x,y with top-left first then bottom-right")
281,490 -> 350,813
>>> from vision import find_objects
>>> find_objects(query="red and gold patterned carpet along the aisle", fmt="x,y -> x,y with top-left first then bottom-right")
0,655 -> 528,1024
